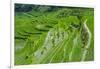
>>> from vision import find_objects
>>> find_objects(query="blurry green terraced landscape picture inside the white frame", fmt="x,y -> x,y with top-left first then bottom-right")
14,4 -> 94,65
